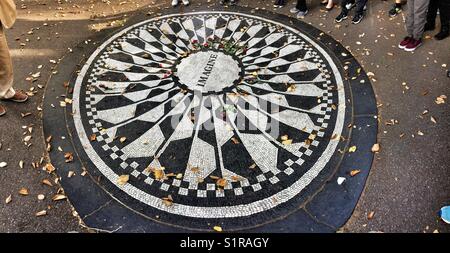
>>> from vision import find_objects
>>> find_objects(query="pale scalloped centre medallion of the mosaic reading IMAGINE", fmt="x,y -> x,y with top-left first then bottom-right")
177,51 -> 241,93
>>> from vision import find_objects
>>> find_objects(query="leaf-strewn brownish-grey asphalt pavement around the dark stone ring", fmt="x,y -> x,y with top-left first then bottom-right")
0,0 -> 450,232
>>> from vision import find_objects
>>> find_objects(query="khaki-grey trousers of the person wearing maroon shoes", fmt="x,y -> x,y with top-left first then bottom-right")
406,0 -> 430,40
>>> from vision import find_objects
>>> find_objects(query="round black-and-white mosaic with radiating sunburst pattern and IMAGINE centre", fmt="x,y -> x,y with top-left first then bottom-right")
73,12 -> 346,226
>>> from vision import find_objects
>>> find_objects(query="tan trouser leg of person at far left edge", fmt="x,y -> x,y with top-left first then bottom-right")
0,23 -> 15,99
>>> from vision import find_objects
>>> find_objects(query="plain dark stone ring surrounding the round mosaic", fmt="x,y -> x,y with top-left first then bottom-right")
43,6 -> 378,232
